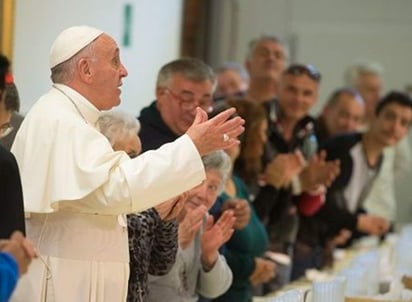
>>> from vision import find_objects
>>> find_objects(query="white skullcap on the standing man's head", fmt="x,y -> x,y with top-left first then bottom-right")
49,25 -> 103,69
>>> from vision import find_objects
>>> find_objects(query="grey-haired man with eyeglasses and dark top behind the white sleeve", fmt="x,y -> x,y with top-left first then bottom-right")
139,58 -> 216,152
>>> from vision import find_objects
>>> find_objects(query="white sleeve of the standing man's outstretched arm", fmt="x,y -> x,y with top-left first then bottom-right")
59,135 -> 205,214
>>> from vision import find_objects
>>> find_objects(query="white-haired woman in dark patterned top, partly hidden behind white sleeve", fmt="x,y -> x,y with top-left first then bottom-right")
98,111 -> 185,302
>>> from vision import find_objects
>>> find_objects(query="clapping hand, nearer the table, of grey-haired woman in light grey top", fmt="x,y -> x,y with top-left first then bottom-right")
200,210 -> 235,271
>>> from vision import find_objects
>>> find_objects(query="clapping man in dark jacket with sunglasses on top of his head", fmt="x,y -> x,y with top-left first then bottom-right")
255,64 -> 339,284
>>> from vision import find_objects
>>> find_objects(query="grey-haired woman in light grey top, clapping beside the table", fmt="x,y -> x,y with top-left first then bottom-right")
149,151 -> 235,302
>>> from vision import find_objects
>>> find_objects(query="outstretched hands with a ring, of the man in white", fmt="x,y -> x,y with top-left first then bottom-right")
186,107 -> 245,155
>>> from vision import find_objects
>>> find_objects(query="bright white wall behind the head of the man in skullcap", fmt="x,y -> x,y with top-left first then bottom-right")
13,0 -> 182,116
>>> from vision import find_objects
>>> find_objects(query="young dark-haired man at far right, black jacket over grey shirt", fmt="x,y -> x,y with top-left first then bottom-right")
318,92 -> 412,243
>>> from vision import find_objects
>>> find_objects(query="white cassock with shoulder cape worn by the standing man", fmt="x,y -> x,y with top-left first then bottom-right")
11,85 -> 205,302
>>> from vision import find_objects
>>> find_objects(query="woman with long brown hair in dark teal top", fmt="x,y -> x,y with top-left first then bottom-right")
212,98 -> 301,302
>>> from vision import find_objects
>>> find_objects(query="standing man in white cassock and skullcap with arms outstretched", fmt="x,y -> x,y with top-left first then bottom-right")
12,26 -> 243,302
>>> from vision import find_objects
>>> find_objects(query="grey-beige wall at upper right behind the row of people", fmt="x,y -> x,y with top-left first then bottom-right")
210,0 -> 412,222
